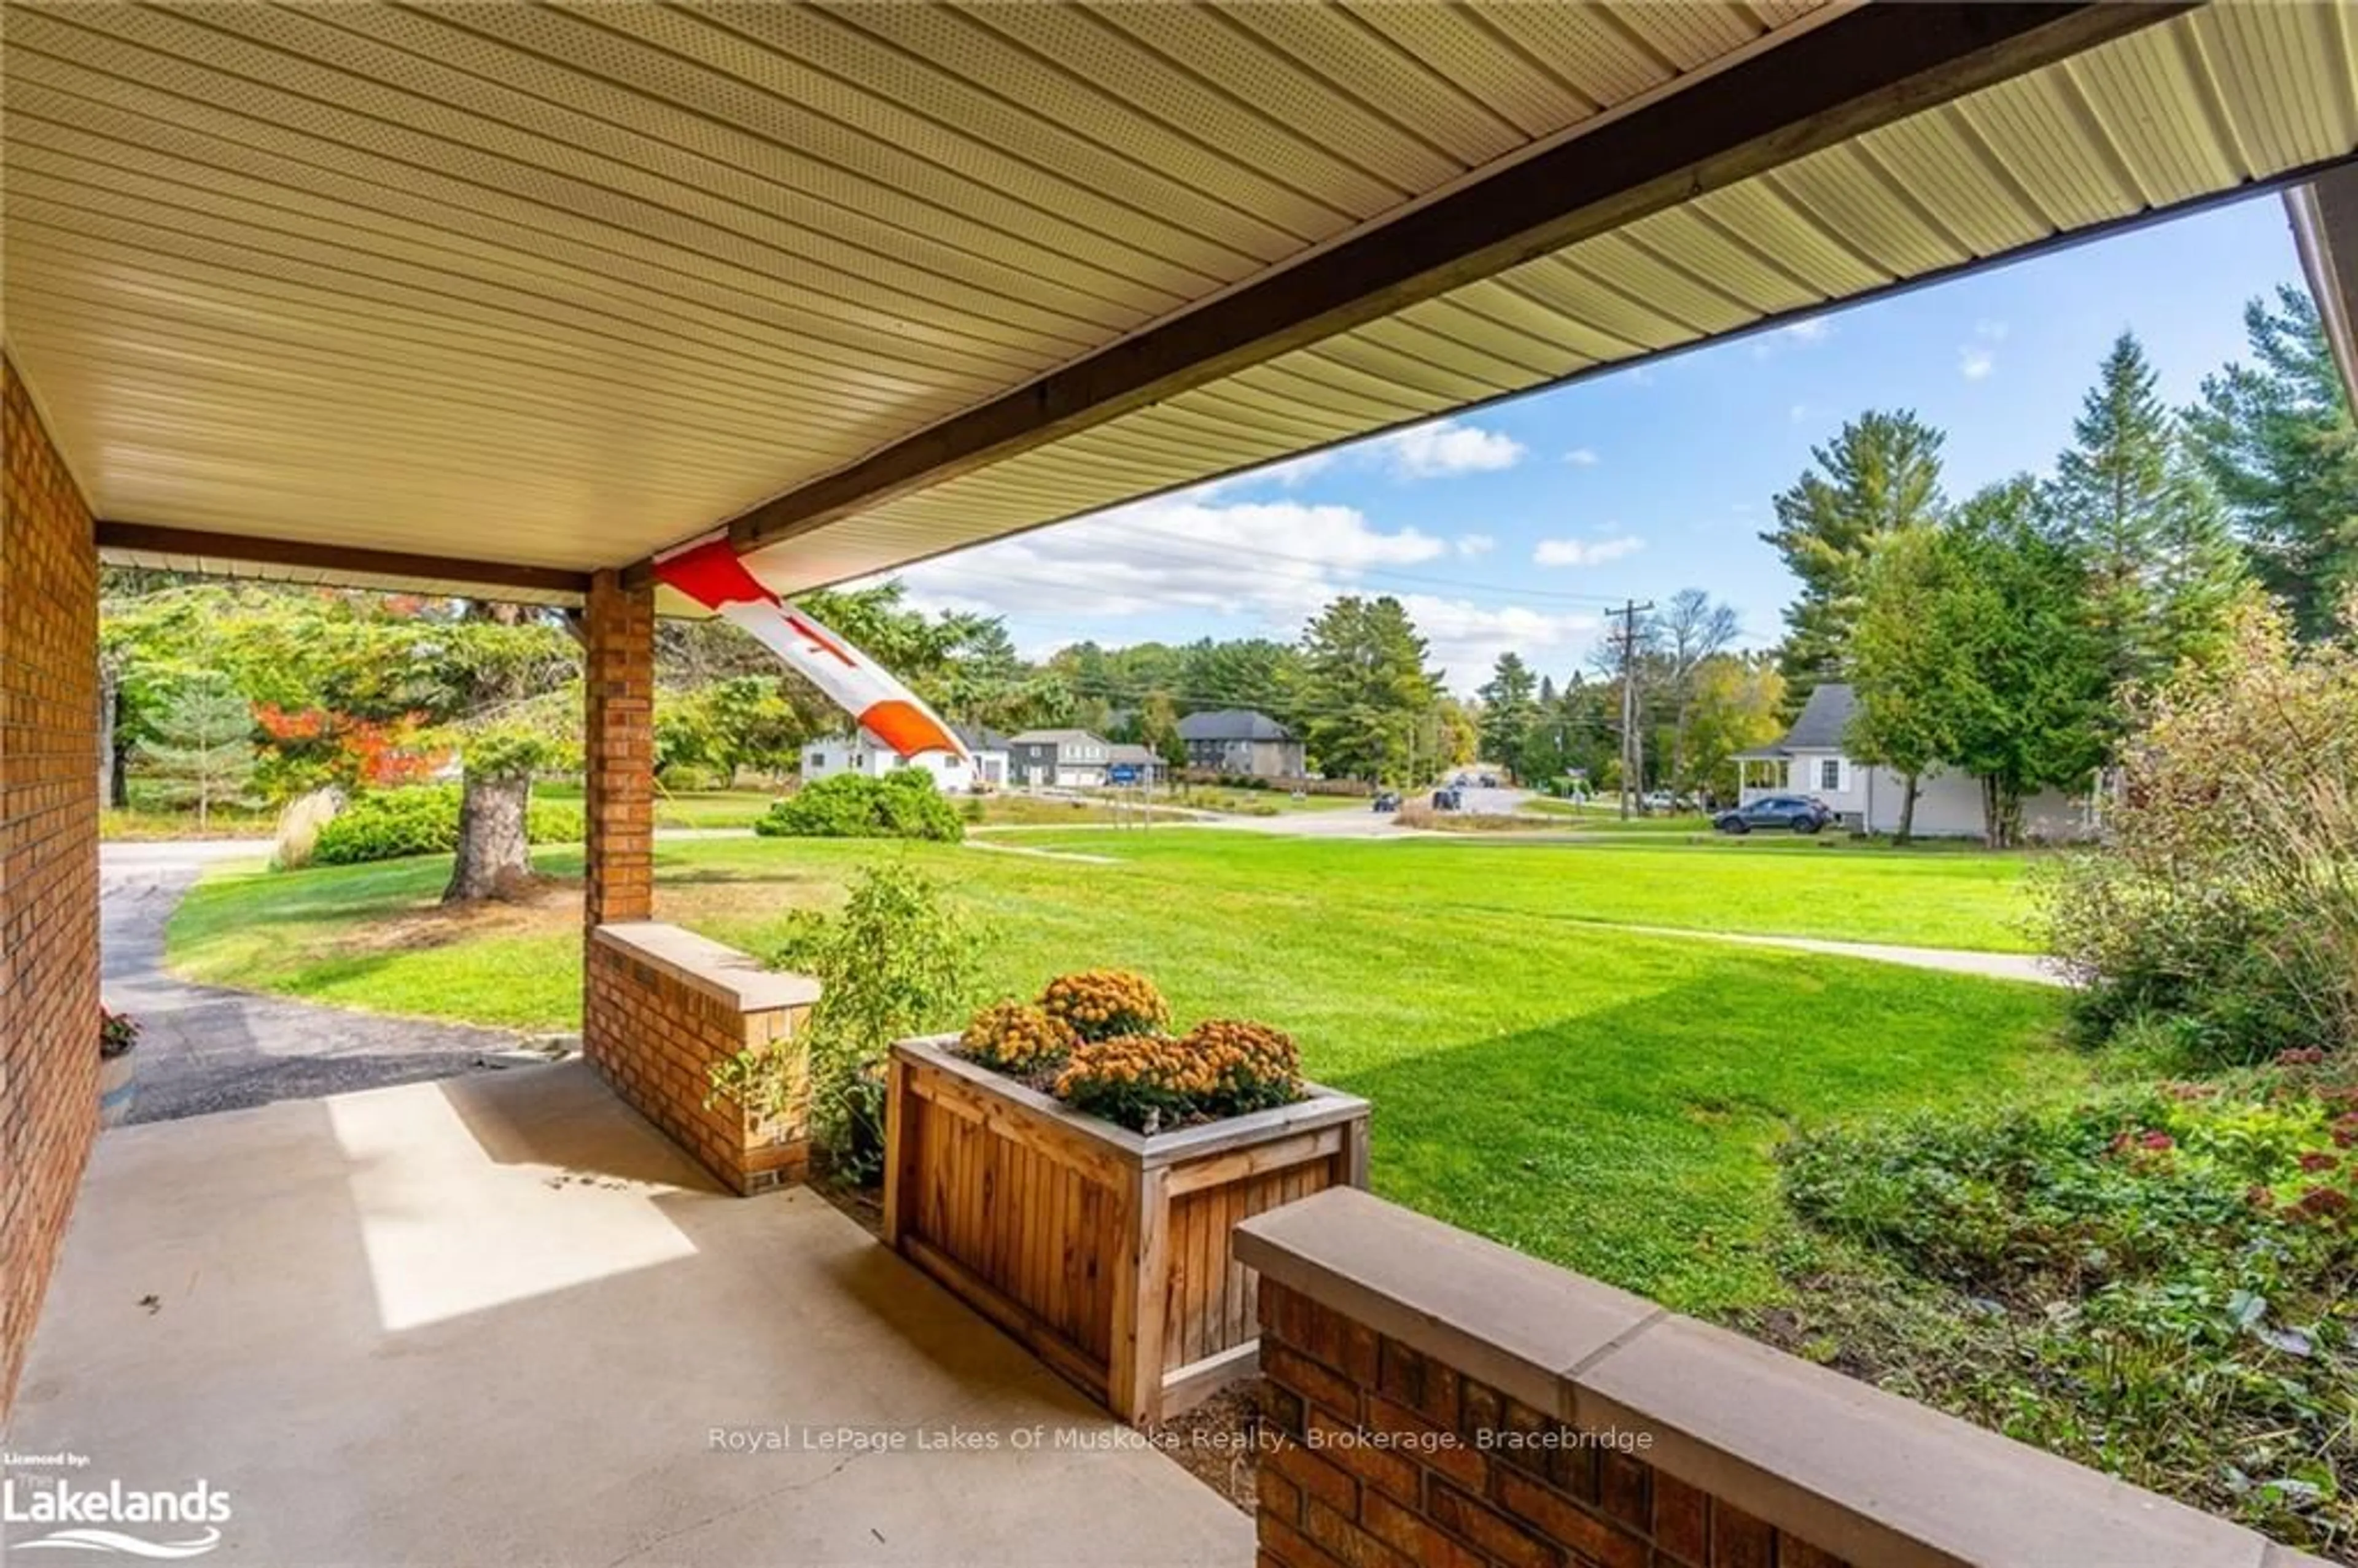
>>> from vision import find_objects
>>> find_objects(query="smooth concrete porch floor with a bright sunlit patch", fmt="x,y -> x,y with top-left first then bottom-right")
0,1063 -> 1252,1568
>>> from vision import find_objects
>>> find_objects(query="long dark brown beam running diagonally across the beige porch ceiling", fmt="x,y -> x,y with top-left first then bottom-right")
707,0 -> 2190,563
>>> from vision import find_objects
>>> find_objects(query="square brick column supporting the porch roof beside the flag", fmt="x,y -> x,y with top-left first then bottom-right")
582,570 -> 656,929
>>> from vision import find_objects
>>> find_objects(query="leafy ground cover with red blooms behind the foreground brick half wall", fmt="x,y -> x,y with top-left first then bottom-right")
1771,1054 -> 2358,1556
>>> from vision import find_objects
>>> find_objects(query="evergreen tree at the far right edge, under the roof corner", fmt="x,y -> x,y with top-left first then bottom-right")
2186,283 -> 2358,639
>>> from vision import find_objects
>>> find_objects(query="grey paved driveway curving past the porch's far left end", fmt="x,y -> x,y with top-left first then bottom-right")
99,842 -> 526,1122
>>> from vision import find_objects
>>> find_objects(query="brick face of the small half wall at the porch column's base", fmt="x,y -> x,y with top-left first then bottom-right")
582,934 -> 811,1193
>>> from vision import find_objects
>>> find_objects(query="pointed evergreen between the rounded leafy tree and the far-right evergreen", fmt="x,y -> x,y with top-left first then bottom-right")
2047,333 -> 2243,721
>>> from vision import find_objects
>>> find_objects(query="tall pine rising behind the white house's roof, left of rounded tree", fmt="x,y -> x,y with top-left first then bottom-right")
1761,410 -> 1943,712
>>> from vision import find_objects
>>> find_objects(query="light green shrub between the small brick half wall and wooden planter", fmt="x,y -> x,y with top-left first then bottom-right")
710,867 -> 983,1179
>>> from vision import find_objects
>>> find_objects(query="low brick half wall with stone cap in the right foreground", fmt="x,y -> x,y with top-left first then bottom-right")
1235,1189 -> 2325,1568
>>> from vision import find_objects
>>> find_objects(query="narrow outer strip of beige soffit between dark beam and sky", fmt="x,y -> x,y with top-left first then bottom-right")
752,0 -> 2358,589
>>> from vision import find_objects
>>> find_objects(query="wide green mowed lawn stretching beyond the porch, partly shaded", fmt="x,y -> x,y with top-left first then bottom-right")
169,830 -> 2082,1311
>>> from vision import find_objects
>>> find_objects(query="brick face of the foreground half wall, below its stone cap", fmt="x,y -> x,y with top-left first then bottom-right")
1259,1278 -> 1844,1568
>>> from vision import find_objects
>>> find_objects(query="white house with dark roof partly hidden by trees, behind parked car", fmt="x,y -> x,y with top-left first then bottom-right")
1735,681 -> 2091,839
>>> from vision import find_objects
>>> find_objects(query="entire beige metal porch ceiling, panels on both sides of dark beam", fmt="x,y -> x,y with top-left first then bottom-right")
0,0 -> 2358,604
